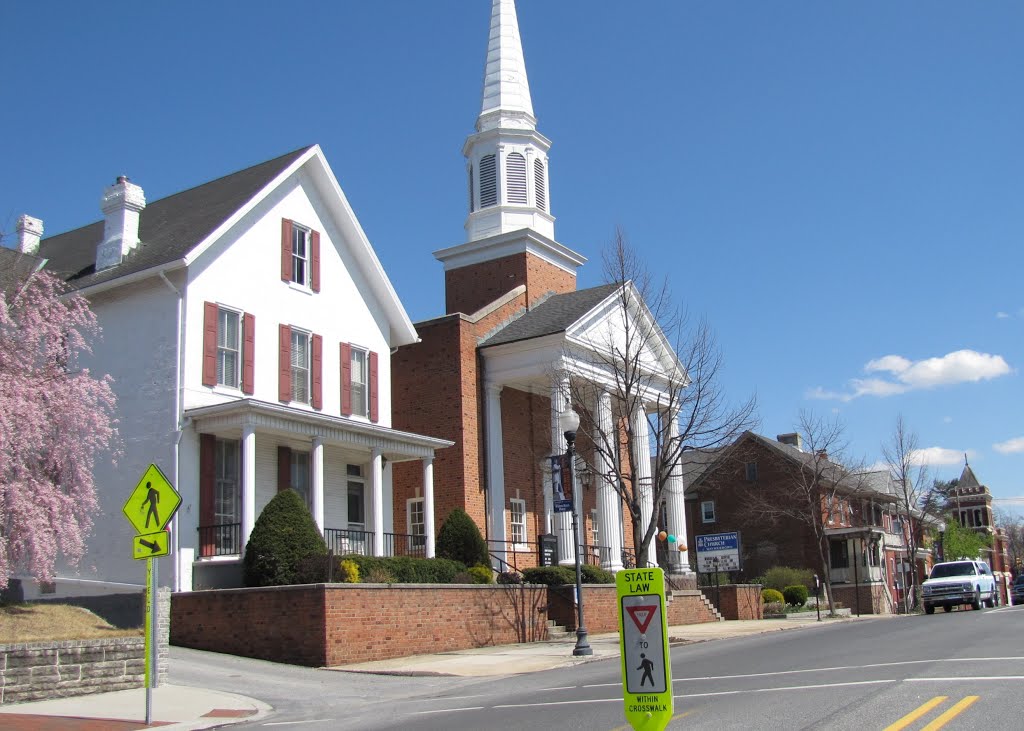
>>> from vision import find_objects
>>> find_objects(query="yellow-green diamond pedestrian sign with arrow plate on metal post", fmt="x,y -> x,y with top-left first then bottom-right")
122,465 -> 181,726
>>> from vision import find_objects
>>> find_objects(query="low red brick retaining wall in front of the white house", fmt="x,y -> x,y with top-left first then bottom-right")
171,584 -> 548,668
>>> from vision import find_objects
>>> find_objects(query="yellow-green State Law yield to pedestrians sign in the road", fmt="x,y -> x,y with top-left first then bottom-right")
615,568 -> 675,731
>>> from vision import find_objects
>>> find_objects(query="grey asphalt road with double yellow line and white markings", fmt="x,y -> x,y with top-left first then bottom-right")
170,606 -> 1024,731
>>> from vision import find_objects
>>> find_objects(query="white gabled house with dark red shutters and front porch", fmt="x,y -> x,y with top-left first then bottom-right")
26,145 -> 452,595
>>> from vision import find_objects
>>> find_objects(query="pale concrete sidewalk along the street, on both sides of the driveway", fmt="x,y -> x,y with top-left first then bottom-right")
0,613 -> 883,731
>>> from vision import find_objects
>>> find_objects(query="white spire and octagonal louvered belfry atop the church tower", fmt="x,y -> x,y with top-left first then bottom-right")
463,0 -> 555,242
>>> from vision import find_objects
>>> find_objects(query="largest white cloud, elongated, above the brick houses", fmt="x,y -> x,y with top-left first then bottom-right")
807,350 -> 1012,401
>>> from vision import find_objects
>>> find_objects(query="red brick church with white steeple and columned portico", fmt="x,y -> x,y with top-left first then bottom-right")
392,0 -> 688,571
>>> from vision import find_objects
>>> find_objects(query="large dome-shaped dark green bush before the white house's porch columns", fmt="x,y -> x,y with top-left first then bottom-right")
243,489 -> 327,587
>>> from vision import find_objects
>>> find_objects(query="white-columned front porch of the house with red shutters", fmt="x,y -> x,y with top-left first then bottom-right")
178,399 -> 452,587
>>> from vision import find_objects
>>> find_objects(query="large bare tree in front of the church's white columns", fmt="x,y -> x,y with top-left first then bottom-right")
562,230 -> 756,566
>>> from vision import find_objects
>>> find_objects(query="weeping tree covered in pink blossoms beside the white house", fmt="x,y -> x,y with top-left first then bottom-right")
0,262 -> 117,588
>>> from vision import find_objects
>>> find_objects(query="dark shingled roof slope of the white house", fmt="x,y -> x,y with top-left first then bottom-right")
39,145 -> 314,289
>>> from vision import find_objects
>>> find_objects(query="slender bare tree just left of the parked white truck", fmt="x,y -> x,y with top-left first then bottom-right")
882,414 -> 943,608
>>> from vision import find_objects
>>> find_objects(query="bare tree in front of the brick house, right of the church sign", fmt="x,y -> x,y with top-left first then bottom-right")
743,412 -> 866,614
